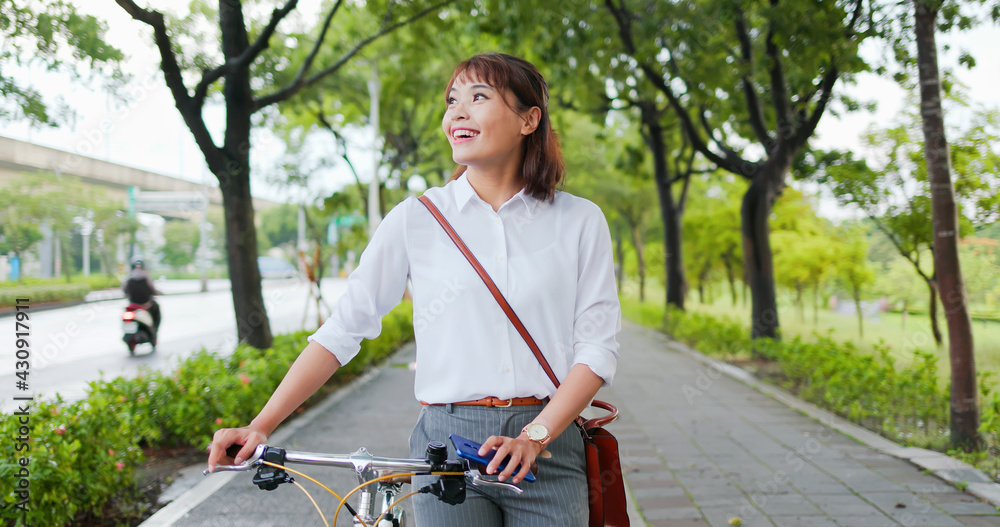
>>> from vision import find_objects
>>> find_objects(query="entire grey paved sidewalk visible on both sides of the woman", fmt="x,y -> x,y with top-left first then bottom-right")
147,323 -> 1000,527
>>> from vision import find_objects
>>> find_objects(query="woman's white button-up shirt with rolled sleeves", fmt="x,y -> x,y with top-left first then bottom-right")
309,175 -> 621,403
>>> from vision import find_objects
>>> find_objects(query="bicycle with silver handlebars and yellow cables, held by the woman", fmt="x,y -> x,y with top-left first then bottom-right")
203,436 -> 535,527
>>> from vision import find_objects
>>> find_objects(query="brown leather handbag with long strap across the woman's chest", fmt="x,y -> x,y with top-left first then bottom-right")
419,196 -> 629,527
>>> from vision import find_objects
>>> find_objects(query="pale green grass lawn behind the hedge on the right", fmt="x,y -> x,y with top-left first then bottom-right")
622,283 -> 1000,387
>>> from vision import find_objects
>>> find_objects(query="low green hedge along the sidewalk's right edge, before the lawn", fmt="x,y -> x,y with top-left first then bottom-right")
622,299 -> 1000,479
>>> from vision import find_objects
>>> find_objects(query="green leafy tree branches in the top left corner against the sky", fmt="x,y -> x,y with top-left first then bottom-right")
0,0 -> 125,126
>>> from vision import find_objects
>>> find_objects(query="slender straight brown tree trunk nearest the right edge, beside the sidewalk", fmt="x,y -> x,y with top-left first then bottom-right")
914,0 -> 981,448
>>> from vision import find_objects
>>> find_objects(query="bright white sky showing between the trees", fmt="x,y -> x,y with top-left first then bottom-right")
0,0 -> 1000,219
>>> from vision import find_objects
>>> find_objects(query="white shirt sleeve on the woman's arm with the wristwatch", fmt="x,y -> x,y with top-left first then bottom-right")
573,205 -> 621,386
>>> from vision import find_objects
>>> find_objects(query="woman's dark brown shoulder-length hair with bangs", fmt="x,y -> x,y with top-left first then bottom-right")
445,53 -> 566,201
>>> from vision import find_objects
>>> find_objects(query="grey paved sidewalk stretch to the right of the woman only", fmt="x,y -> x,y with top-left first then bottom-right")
609,324 -> 1000,527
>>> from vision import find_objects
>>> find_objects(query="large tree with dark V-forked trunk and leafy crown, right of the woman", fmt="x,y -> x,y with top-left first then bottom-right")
605,0 -> 872,338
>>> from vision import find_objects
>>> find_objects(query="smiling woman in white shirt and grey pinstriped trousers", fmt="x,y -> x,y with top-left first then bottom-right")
209,53 -> 620,527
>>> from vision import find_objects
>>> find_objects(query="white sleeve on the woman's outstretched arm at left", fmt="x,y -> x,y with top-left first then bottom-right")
308,200 -> 410,365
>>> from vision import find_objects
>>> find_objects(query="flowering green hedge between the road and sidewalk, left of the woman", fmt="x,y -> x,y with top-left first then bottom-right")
0,302 -> 413,525
